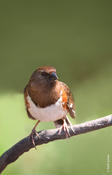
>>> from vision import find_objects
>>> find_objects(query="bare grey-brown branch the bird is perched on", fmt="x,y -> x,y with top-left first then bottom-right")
0,115 -> 112,173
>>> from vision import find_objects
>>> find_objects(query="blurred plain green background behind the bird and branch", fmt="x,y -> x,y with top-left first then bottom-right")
0,0 -> 112,175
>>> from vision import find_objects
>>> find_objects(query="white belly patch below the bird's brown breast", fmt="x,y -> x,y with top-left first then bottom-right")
27,95 -> 67,122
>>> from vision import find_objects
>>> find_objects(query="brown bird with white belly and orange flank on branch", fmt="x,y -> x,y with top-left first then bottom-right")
24,66 -> 75,146
